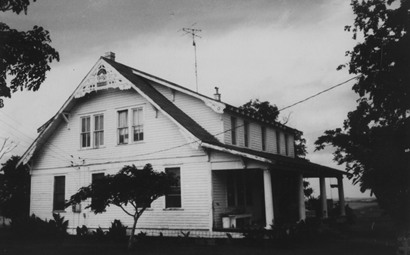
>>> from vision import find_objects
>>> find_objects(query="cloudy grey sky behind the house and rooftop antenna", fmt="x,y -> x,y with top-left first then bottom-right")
0,0 -> 369,198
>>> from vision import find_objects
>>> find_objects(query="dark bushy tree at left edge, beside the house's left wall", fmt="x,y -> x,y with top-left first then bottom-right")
0,156 -> 30,220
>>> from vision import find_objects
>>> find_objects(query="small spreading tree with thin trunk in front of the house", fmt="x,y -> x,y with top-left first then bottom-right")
66,164 -> 176,249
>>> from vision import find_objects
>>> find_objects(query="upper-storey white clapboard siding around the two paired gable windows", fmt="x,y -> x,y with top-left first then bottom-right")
35,89 -> 203,169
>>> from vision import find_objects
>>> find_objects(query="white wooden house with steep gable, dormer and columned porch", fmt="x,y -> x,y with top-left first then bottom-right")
20,53 -> 344,236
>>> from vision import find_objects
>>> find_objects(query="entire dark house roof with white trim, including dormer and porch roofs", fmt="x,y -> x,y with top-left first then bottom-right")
19,54 -> 344,176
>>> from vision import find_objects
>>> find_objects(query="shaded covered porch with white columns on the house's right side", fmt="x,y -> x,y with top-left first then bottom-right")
208,149 -> 345,231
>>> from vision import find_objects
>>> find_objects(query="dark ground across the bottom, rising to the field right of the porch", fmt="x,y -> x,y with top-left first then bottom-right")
0,201 -> 395,255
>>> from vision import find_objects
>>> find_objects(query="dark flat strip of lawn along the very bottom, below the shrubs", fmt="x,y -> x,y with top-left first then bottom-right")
0,240 -> 395,255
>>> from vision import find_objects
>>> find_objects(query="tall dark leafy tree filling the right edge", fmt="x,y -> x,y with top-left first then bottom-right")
315,0 -> 410,231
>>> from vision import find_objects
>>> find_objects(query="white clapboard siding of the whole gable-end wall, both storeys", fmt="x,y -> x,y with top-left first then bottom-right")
31,89 -> 216,229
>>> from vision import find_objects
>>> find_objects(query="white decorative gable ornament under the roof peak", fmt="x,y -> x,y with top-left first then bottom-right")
74,60 -> 131,98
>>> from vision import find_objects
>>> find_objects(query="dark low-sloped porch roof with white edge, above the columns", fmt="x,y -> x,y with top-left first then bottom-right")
202,143 -> 348,177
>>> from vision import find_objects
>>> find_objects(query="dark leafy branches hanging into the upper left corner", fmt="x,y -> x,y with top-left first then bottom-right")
0,0 -> 59,106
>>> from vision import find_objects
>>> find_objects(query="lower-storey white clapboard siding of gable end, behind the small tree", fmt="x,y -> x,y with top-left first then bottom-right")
32,157 -> 211,229
